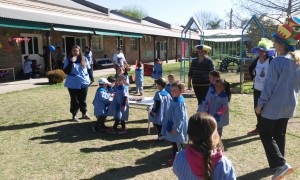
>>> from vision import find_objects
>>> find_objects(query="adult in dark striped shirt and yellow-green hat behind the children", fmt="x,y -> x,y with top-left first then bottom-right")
188,45 -> 215,105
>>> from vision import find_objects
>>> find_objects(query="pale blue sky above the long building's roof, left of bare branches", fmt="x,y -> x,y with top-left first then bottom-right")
88,0 -> 232,25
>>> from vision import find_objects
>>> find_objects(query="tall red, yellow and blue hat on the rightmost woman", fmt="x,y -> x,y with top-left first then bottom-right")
271,16 -> 300,51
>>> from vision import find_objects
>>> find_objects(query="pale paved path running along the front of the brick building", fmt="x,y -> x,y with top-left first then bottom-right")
0,60 -> 175,94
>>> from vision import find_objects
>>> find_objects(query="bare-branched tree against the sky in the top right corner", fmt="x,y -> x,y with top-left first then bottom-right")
236,0 -> 300,23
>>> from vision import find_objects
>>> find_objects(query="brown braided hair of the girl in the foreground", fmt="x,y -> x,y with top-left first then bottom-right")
187,112 -> 224,179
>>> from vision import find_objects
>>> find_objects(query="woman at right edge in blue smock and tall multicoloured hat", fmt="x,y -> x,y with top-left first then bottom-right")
255,17 -> 300,179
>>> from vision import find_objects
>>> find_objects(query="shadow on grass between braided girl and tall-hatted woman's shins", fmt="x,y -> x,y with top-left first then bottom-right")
222,135 -> 260,150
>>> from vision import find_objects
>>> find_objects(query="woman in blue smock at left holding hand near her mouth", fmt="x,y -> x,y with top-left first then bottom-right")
64,45 -> 94,121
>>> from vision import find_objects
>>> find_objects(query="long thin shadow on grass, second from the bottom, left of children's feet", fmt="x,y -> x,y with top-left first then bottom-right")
81,139 -> 171,153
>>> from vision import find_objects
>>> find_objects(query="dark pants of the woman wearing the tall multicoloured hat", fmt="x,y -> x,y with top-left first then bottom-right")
258,117 -> 289,168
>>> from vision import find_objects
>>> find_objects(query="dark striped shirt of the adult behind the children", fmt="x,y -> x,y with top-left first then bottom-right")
189,57 -> 215,86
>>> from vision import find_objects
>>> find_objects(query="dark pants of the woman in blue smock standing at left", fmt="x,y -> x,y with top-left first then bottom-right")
68,87 -> 88,116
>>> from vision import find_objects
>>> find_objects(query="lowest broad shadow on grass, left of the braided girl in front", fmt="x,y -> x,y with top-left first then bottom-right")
91,149 -> 171,180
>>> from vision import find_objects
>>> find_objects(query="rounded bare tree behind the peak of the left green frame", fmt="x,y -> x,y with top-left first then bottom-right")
194,11 -> 222,29
